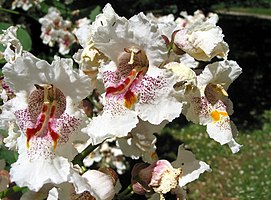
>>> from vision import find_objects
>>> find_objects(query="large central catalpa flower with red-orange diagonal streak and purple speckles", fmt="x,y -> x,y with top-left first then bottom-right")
84,4 -> 181,144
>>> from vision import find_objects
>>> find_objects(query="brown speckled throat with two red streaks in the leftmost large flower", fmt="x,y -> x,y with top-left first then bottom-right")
26,84 -> 66,148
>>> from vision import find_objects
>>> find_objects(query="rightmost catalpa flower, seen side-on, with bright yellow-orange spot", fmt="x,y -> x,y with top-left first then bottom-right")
184,61 -> 241,153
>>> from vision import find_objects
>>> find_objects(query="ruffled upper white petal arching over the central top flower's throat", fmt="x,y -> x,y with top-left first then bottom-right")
93,4 -> 167,66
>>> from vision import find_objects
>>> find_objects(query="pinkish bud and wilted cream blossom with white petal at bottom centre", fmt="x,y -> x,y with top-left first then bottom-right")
132,146 -> 211,200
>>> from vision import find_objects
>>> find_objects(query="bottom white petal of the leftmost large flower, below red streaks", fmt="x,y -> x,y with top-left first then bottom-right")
10,135 -> 70,191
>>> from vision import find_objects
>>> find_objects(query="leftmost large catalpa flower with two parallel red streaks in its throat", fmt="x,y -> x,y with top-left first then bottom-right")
3,53 -> 91,191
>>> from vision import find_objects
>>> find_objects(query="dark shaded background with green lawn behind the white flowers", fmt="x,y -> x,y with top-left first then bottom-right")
0,0 -> 271,199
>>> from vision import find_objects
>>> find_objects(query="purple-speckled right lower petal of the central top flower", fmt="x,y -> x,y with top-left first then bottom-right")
135,67 -> 182,125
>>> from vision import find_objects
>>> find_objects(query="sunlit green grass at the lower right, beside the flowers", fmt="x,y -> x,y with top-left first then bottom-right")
164,125 -> 271,200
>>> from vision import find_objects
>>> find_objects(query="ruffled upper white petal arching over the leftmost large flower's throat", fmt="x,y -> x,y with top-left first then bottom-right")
3,54 -> 91,103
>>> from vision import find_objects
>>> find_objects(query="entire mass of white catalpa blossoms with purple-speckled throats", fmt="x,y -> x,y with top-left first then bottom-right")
0,4 -> 241,199
